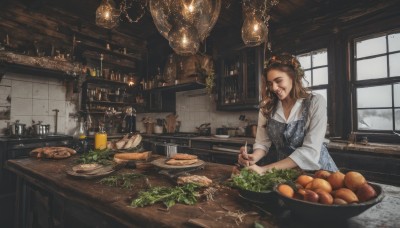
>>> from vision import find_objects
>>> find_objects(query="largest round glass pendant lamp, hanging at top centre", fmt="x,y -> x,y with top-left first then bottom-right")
149,0 -> 221,55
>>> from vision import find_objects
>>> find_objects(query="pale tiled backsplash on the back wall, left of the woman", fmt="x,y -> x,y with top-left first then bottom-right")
136,89 -> 258,134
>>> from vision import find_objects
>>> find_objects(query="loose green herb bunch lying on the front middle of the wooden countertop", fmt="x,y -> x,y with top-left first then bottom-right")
131,183 -> 200,208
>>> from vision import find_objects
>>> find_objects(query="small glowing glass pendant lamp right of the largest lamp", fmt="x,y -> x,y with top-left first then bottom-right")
242,13 -> 268,47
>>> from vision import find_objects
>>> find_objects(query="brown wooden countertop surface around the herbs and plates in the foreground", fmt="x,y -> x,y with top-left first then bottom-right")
7,158 -> 400,227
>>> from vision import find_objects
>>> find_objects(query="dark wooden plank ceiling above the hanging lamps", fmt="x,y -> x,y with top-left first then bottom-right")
0,0 -> 400,60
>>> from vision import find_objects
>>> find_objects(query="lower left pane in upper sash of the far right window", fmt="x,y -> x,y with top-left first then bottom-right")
357,56 -> 387,80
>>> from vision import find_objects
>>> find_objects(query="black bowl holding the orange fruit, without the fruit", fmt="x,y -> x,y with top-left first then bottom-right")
274,183 -> 384,221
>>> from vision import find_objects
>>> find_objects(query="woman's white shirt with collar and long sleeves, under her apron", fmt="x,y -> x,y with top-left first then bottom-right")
253,94 -> 327,170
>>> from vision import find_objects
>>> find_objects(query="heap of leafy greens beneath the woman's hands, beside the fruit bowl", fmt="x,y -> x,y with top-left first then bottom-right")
230,169 -> 300,192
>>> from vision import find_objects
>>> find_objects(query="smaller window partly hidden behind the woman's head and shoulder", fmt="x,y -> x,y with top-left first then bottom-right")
297,49 -> 328,103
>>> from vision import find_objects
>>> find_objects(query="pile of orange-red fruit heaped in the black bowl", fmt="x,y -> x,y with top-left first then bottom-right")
277,170 -> 377,205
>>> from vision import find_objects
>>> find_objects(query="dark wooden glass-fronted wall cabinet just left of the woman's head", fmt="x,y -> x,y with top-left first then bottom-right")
217,47 -> 264,111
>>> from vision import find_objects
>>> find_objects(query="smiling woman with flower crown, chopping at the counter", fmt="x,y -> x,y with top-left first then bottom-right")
238,54 -> 338,174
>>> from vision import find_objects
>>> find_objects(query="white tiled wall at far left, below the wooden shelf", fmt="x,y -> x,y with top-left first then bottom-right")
0,73 -> 79,135
